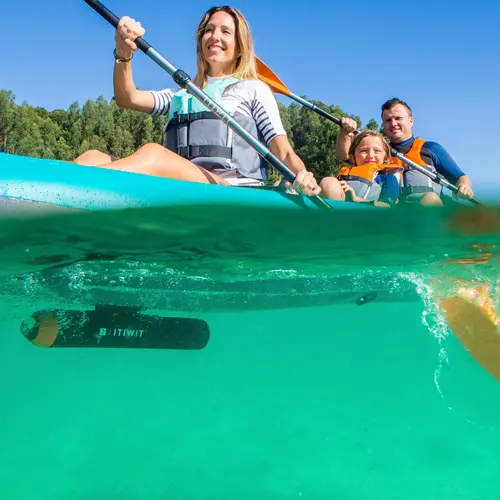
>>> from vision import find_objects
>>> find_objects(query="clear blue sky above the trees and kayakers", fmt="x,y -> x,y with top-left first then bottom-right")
0,0 -> 500,194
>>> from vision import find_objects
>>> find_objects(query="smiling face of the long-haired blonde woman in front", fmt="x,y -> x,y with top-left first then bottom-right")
201,11 -> 239,76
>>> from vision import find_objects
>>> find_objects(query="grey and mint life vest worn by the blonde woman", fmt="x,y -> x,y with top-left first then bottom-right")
162,77 -> 268,180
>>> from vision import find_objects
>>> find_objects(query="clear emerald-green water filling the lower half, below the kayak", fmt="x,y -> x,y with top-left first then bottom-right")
0,198 -> 500,500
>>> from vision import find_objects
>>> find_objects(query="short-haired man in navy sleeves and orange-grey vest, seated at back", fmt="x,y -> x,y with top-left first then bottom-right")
336,98 -> 474,205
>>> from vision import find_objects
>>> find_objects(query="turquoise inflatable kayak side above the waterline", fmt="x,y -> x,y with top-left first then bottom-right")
0,154 -> 373,210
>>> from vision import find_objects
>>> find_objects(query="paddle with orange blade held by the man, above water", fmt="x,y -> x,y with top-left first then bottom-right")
255,58 -> 481,205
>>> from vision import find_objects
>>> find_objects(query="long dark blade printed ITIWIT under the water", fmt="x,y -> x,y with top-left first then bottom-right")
21,306 -> 210,350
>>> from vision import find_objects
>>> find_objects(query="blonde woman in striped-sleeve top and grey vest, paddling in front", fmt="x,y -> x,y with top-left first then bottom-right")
75,6 -> 321,196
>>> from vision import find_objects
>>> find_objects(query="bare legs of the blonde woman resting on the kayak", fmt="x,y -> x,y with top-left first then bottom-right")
75,143 -> 230,186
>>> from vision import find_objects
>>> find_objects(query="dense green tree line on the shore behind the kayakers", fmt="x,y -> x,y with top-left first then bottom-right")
0,90 -> 379,181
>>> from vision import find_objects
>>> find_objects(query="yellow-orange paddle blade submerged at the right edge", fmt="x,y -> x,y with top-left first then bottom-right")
440,296 -> 500,381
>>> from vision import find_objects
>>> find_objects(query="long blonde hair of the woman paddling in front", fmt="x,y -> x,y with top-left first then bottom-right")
194,5 -> 257,88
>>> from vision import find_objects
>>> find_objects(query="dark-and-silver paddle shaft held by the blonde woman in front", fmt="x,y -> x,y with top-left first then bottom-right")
85,0 -> 332,210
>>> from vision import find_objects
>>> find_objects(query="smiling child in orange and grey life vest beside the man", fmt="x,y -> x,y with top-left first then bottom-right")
321,130 -> 401,207
